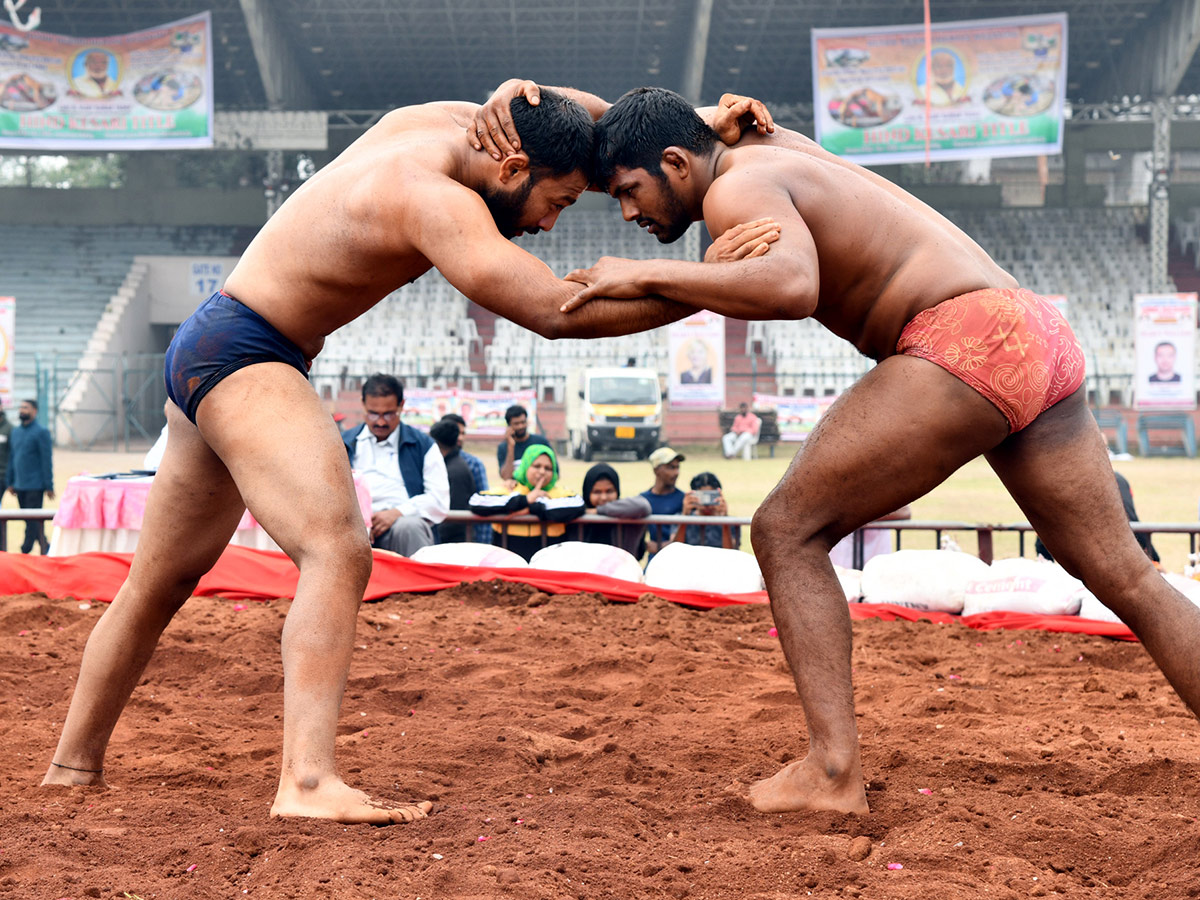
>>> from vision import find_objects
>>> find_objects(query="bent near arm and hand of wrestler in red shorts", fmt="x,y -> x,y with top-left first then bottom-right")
566,170 -> 821,319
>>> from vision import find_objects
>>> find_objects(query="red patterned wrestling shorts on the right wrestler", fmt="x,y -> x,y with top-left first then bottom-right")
896,288 -> 1084,432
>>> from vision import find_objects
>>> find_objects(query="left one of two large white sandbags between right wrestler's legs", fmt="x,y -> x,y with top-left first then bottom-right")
863,550 -> 988,613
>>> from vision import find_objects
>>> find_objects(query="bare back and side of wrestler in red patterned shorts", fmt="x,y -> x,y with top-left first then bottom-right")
725,128 -> 1016,359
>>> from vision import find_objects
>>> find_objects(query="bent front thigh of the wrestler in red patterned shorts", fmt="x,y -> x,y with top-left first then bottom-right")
768,356 -> 1008,546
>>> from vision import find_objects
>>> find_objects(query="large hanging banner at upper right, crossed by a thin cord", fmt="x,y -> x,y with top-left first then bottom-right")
812,13 -> 1067,166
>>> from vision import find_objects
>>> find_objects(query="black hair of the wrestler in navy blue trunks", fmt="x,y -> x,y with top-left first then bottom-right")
509,88 -> 593,181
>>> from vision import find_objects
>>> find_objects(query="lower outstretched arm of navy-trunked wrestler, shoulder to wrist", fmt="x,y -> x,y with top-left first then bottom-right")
401,176 -> 696,338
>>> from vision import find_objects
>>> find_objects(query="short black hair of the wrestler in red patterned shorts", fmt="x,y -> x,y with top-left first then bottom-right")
592,88 -> 716,187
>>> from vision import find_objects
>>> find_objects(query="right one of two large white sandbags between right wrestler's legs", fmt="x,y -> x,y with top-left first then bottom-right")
962,558 -> 1082,616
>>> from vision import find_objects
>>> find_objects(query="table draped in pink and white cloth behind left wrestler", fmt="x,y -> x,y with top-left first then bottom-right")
49,475 -> 371,557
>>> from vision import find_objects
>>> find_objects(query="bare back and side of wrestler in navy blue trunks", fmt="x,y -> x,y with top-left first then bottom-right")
224,103 -> 470,356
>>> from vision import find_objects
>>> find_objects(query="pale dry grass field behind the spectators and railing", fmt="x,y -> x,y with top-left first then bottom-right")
4,443 -> 1200,571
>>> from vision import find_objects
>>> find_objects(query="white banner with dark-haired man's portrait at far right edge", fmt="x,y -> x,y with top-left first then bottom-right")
1133,294 -> 1196,410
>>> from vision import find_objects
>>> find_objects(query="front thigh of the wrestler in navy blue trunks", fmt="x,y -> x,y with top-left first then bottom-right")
197,362 -> 366,558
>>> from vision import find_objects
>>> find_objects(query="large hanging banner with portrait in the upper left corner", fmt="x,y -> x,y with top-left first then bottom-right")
0,12 -> 212,150
